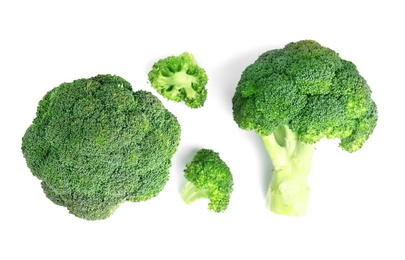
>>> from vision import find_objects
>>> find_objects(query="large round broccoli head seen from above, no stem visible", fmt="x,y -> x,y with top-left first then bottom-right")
22,75 -> 180,220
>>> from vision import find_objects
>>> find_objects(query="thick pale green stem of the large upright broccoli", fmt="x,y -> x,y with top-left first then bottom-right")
261,126 -> 315,216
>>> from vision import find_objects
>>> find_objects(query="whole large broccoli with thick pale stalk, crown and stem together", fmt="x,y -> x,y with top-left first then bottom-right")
232,40 -> 377,216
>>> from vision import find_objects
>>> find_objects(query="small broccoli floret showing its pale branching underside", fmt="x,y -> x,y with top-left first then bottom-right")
148,52 -> 208,108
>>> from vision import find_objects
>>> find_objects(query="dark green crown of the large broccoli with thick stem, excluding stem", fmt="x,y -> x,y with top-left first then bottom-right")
233,40 -> 377,152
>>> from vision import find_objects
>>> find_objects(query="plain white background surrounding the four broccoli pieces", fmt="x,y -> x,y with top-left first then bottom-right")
0,0 -> 405,260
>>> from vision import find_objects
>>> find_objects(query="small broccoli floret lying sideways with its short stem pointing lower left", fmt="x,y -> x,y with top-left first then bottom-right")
181,149 -> 233,212
